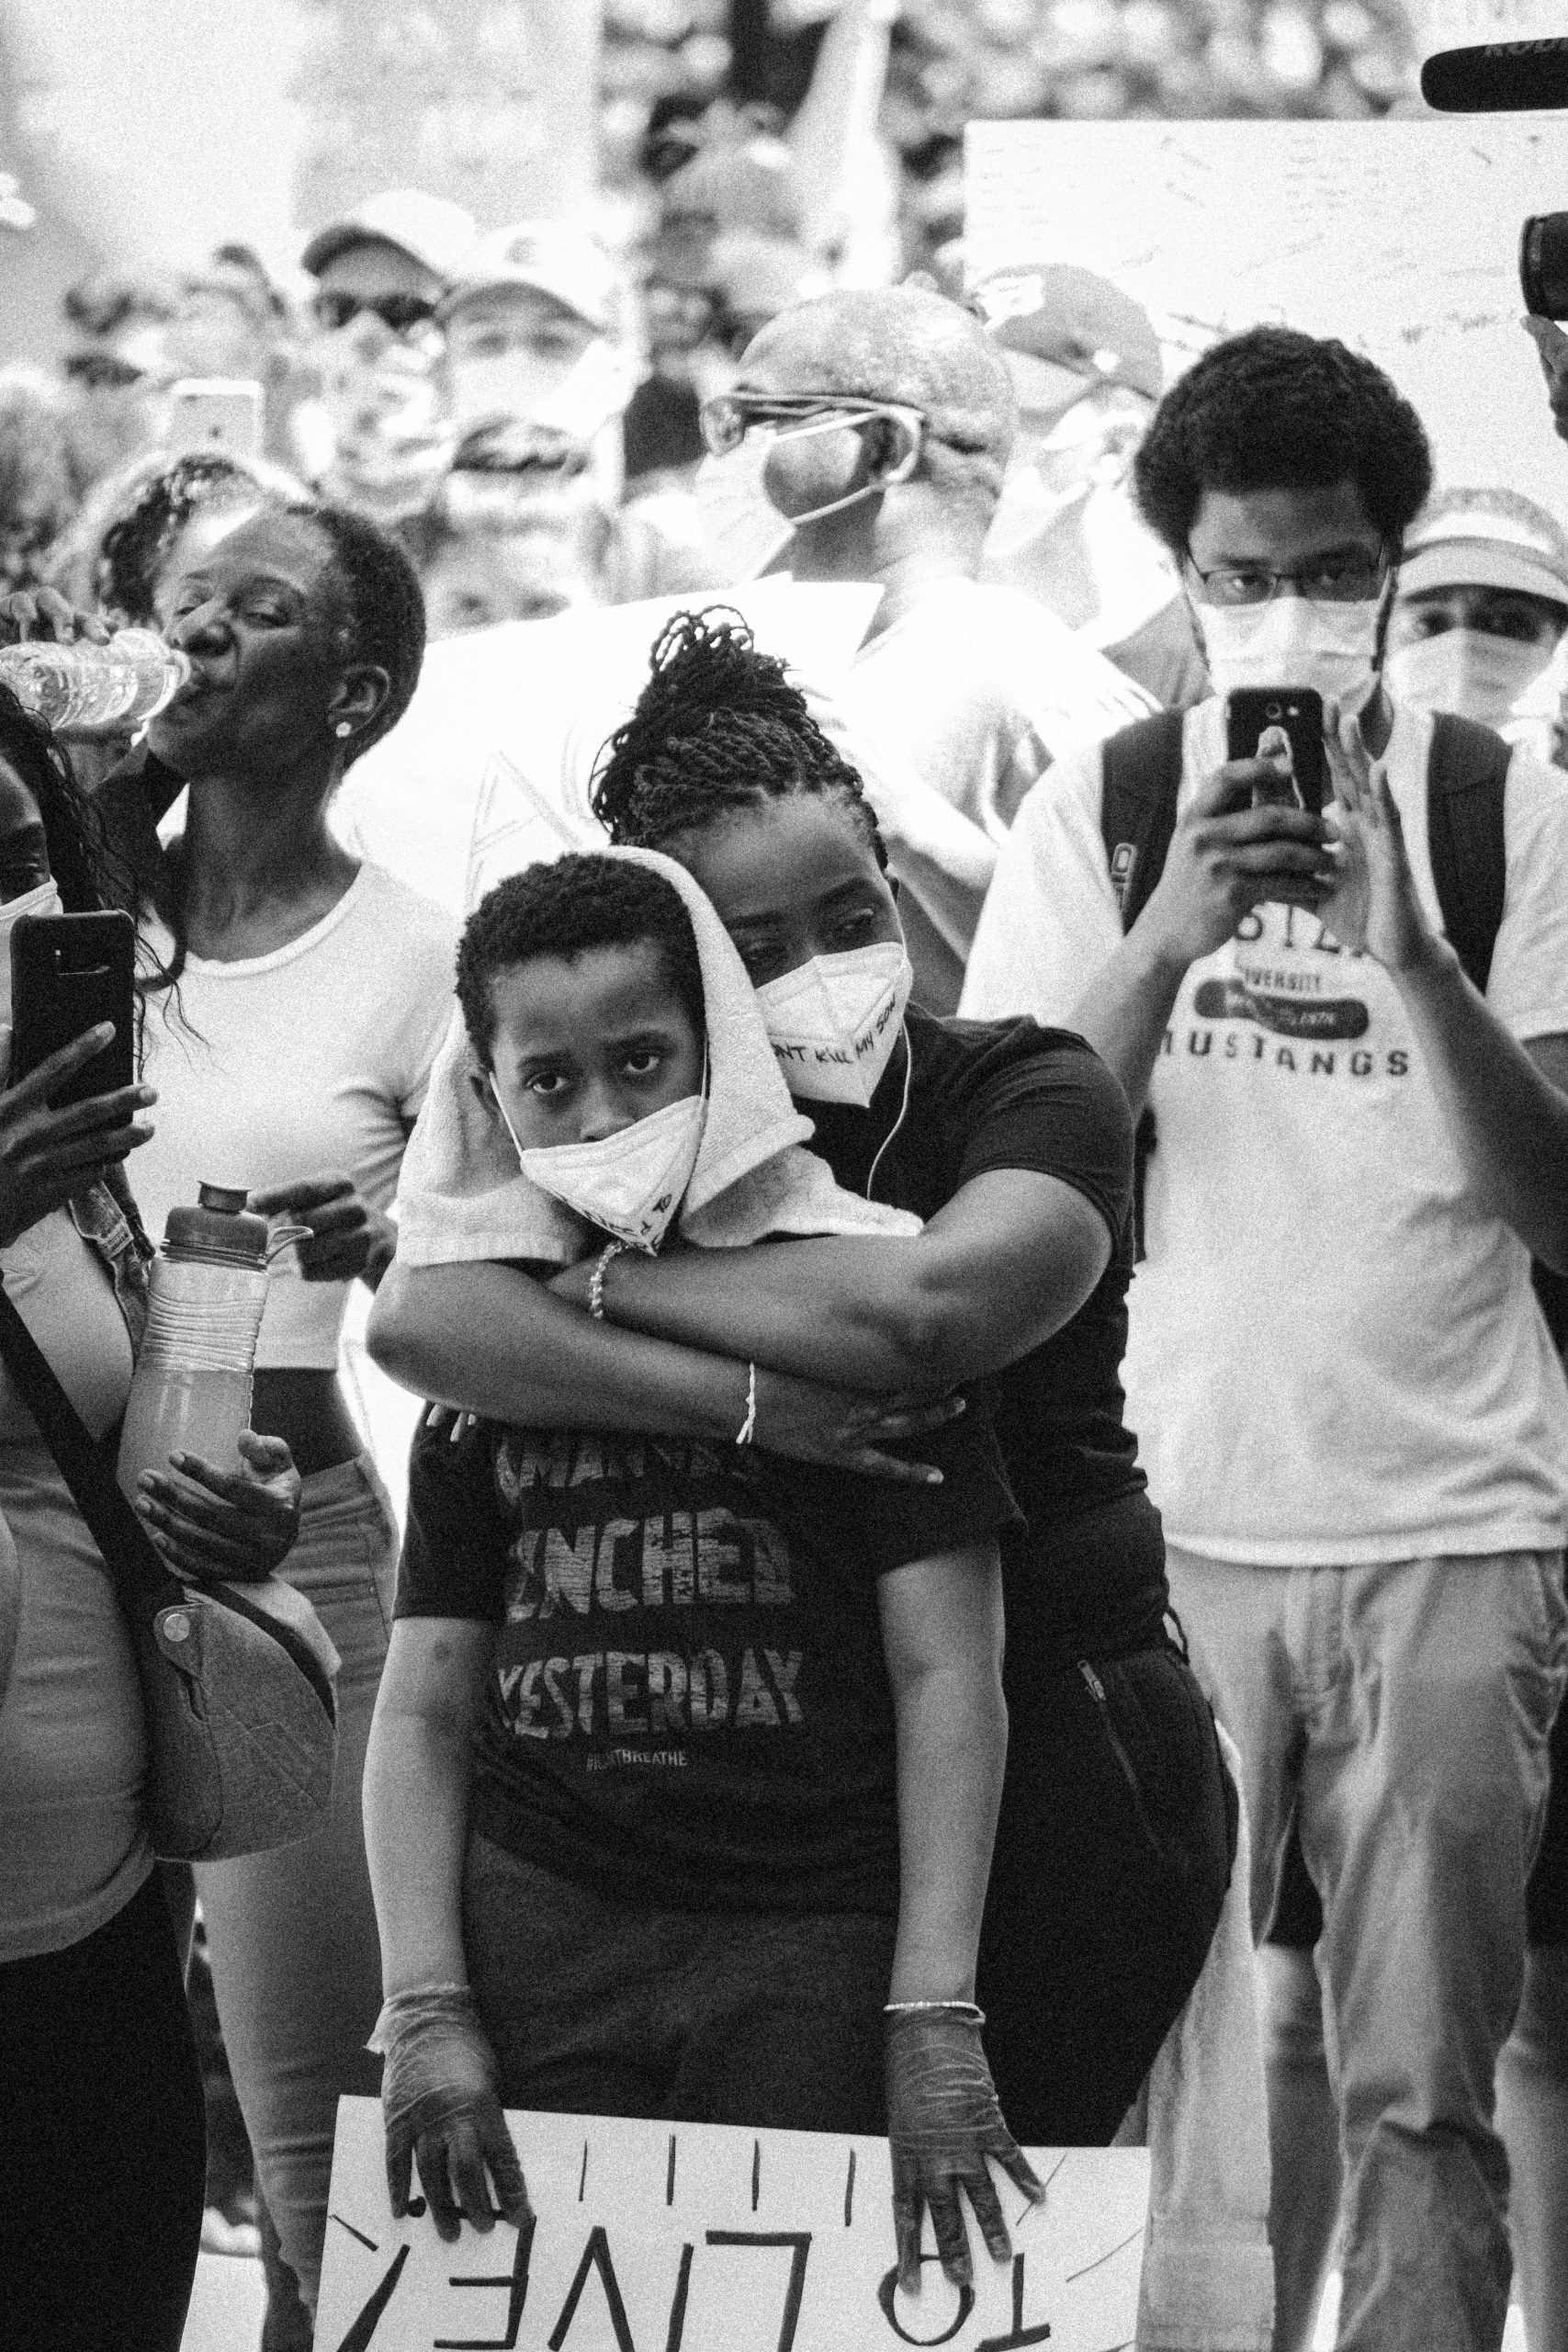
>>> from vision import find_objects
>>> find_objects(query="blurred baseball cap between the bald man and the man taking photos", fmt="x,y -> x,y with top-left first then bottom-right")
974,261 -> 1166,414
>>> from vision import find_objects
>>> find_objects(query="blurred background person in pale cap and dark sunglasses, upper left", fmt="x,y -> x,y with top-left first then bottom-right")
301,188 -> 475,526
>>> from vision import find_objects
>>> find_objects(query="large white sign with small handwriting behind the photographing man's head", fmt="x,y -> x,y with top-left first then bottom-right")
964,115 -> 1568,513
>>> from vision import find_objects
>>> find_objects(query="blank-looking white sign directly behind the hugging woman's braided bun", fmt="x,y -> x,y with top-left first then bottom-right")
333,579 -> 882,912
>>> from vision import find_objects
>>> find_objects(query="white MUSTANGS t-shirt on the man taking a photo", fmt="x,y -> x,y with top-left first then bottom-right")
962,701 -> 1568,1566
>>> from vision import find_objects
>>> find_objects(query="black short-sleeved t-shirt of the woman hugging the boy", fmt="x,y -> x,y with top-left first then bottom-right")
807,1007 -> 1168,1698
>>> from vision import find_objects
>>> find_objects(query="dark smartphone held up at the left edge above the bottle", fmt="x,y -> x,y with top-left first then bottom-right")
9,910 -> 136,1110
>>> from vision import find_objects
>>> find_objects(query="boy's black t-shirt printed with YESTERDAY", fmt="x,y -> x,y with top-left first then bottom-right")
398,1408 -> 1018,1915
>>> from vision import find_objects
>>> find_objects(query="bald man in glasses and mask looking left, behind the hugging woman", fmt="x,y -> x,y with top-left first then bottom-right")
698,287 -> 1155,1013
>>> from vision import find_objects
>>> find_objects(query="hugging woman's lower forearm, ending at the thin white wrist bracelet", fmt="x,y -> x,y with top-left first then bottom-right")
367,1261 -> 748,1440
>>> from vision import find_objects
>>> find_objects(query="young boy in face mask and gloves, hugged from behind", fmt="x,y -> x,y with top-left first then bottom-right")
367,854 -> 1037,2286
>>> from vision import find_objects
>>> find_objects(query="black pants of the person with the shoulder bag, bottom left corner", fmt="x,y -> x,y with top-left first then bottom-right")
0,1874 -> 207,2352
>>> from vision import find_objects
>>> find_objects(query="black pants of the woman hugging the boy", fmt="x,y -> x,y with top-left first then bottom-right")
978,1644 -> 1236,2147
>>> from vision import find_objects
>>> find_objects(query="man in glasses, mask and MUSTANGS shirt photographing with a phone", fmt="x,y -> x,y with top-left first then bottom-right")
964,327 -> 1568,2352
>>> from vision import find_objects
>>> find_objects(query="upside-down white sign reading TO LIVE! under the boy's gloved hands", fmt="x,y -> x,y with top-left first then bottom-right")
315,2098 -> 1149,2352
